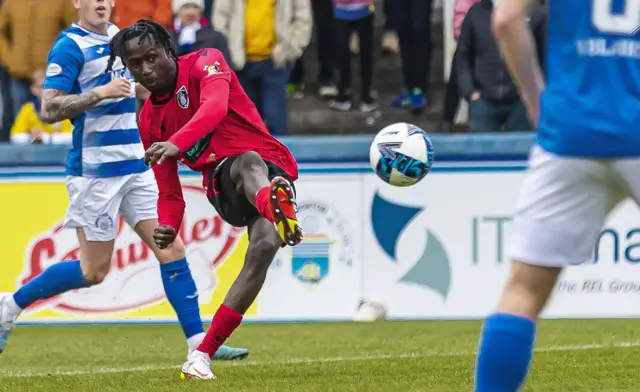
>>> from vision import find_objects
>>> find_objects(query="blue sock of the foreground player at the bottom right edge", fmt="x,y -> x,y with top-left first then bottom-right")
474,313 -> 536,392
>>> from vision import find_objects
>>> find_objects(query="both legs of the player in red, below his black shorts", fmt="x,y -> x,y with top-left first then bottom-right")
181,153 -> 302,379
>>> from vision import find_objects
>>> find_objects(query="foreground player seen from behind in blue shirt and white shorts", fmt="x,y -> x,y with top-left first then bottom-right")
474,0 -> 640,392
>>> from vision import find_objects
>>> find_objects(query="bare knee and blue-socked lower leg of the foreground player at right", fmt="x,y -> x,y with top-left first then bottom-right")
476,261 -> 562,391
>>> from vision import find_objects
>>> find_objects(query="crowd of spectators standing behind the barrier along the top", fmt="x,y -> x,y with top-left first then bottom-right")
0,0 -> 546,143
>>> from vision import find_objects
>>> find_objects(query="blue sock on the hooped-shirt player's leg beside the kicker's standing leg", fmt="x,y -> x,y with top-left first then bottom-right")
160,259 -> 204,339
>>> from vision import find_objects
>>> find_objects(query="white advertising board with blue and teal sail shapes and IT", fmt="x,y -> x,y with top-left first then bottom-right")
362,167 -> 640,319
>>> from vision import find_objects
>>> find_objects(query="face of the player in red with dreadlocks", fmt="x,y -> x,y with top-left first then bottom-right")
123,38 -> 175,95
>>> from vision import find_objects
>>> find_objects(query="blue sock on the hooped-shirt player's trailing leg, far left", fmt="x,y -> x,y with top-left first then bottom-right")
13,260 -> 87,309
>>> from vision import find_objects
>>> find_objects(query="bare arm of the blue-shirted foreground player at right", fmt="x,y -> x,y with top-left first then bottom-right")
493,0 -> 544,124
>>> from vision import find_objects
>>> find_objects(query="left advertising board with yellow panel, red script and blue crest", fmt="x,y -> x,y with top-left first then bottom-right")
0,172 -> 362,322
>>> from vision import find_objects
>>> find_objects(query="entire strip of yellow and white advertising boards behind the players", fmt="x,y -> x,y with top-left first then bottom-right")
0,163 -> 640,323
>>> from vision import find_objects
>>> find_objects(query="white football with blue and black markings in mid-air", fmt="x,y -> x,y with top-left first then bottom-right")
369,123 -> 434,186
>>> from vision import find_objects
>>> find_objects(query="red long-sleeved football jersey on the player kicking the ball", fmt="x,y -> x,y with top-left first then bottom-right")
139,49 -> 298,231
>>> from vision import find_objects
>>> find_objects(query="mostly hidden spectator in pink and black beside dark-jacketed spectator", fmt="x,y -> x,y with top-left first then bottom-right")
440,0 -> 480,132
